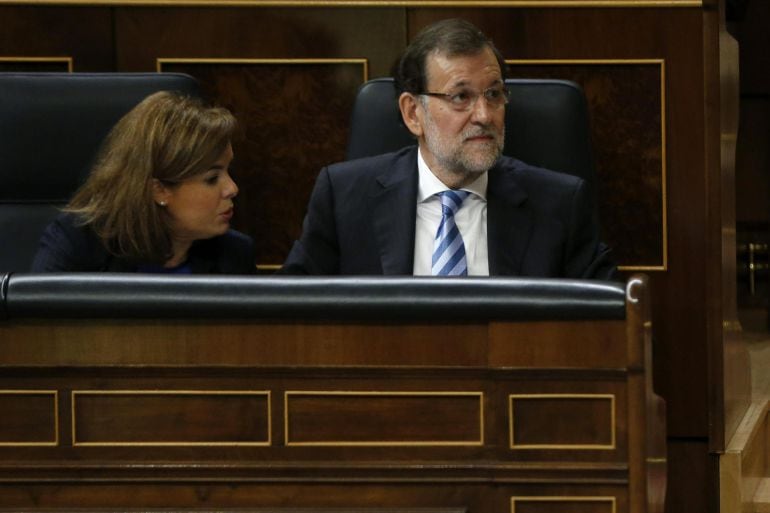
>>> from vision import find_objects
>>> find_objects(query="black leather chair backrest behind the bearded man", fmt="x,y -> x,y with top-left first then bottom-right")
347,78 -> 594,186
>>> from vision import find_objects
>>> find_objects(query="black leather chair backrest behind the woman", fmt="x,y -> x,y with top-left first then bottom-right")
0,72 -> 199,271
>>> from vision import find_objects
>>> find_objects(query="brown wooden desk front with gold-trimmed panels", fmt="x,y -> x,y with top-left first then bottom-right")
0,280 -> 665,513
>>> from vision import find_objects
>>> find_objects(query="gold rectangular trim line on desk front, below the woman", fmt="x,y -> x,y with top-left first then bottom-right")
70,390 -> 273,447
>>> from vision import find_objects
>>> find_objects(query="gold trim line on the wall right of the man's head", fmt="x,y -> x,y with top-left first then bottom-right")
505,59 -> 668,272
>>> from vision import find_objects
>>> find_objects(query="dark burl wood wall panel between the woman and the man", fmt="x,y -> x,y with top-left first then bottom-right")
158,59 -> 367,268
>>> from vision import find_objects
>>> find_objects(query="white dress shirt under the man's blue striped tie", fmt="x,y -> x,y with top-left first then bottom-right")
414,149 -> 489,276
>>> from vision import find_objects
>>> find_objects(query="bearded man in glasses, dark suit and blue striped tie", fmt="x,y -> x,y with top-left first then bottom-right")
282,19 -> 616,279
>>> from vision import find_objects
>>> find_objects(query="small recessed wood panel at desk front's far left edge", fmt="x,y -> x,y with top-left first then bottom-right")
0,390 -> 59,446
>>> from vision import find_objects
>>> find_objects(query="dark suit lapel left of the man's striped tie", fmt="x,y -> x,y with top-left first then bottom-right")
371,147 -> 417,275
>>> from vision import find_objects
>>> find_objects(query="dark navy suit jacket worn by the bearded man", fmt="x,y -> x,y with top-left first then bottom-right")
281,146 -> 616,279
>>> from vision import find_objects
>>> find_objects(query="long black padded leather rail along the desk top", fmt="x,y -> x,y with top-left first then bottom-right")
0,273 -> 625,321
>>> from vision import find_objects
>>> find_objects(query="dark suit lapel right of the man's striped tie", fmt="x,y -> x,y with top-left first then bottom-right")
487,164 -> 533,276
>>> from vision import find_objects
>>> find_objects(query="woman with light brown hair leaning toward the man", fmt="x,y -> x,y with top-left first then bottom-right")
32,91 -> 255,274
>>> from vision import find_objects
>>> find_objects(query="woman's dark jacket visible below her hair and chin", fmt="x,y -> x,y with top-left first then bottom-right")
31,213 -> 256,274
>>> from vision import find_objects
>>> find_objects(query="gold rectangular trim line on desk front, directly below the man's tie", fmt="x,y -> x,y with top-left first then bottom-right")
283,390 -> 484,447
